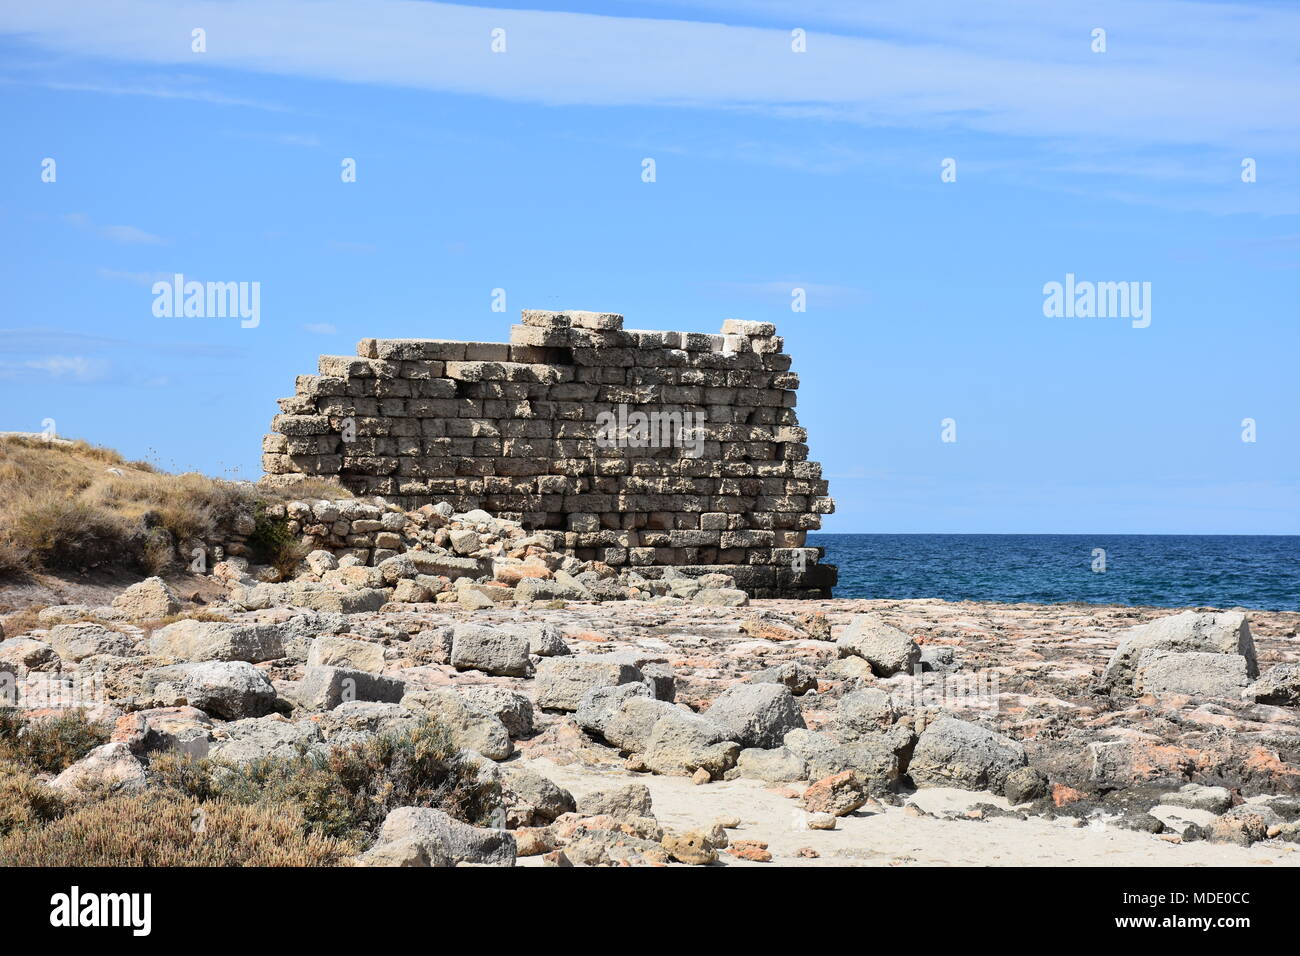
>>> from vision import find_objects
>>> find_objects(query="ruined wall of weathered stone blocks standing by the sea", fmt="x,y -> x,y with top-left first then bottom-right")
263,311 -> 836,597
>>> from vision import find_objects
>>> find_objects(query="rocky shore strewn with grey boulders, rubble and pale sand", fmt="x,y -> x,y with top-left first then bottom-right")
0,502 -> 1300,865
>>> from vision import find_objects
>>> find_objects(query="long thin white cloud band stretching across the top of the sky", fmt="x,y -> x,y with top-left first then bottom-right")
0,0 -> 1300,148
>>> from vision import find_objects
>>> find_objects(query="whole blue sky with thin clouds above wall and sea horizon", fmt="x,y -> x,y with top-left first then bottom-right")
0,0 -> 1300,533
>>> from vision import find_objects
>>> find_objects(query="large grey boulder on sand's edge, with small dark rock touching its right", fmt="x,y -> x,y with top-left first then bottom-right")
907,715 -> 1026,793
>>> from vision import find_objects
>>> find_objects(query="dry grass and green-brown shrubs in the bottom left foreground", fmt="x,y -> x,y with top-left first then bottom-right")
0,714 -> 501,866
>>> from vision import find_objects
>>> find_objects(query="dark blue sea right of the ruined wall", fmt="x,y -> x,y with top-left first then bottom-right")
809,535 -> 1300,611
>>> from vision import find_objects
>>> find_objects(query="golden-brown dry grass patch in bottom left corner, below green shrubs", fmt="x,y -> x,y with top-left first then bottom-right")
0,791 -> 354,866
